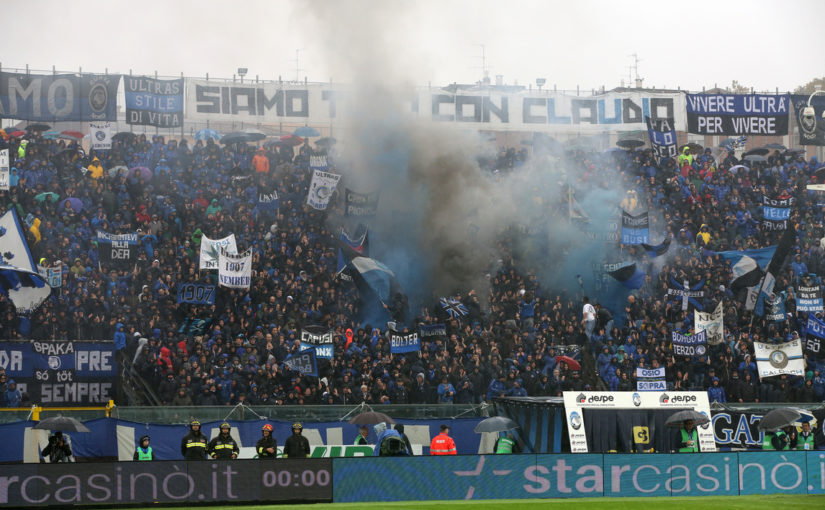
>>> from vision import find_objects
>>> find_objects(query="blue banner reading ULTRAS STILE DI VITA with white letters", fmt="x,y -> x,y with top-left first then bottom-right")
123,76 -> 183,128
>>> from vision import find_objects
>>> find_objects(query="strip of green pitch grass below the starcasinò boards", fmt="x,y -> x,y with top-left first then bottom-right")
112,495 -> 825,510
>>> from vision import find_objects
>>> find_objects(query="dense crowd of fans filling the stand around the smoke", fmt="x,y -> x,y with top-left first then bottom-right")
0,129 -> 825,405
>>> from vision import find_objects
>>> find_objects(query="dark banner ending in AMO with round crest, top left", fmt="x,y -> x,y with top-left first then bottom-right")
0,73 -> 120,122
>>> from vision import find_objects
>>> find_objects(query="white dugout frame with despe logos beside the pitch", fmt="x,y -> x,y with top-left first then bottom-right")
562,391 -> 716,453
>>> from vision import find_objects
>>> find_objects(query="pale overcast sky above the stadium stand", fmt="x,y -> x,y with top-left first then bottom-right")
0,0 -> 825,90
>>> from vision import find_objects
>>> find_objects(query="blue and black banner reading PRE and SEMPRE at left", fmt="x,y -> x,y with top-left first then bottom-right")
0,341 -> 117,406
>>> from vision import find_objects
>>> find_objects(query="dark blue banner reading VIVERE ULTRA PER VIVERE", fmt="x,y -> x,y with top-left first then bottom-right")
687,94 -> 791,136
